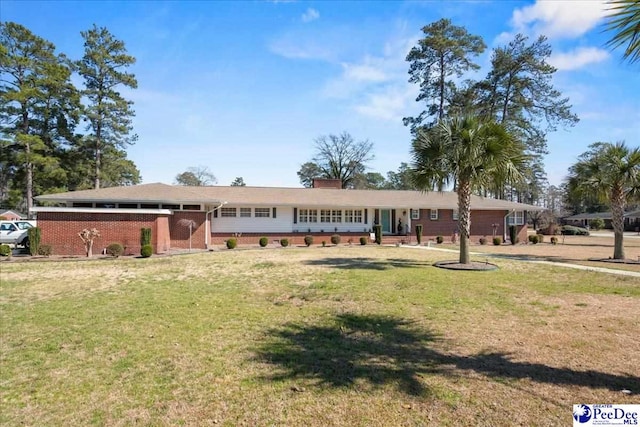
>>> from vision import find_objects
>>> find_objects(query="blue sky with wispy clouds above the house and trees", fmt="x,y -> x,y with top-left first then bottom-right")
0,0 -> 640,187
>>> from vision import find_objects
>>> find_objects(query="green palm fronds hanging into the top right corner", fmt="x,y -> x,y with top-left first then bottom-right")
606,0 -> 640,63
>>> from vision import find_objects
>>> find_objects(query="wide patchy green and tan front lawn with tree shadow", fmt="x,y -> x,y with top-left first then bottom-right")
0,245 -> 640,426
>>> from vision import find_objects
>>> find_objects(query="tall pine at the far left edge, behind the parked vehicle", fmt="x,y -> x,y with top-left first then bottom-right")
0,22 -> 79,213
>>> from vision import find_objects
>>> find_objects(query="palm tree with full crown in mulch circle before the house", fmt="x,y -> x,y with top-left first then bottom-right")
412,116 -> 526,264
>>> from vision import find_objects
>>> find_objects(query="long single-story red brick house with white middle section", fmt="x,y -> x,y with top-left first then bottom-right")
33,180 -> 542,255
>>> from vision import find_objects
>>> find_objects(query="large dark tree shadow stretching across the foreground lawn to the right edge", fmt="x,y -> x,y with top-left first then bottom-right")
252,314 -> 640,396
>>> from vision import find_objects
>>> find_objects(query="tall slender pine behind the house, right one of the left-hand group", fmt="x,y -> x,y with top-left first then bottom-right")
77,25 -> 138,188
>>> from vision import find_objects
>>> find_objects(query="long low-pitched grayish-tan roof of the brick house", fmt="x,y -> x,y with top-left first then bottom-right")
36,183 -> 544,211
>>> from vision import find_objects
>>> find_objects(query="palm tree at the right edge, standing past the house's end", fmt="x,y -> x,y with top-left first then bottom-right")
568,142 -> 640,259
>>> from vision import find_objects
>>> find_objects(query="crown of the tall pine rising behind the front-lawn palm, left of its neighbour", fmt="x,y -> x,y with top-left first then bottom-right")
403,19 -> 486,131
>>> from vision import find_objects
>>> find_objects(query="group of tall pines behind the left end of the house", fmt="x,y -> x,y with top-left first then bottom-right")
0,22 -> 140,212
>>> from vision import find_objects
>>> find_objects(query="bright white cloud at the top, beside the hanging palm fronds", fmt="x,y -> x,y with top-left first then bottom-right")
511,0 -> 607,38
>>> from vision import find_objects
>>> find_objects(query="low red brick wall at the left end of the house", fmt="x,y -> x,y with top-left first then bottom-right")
38,212 -> 170,255
